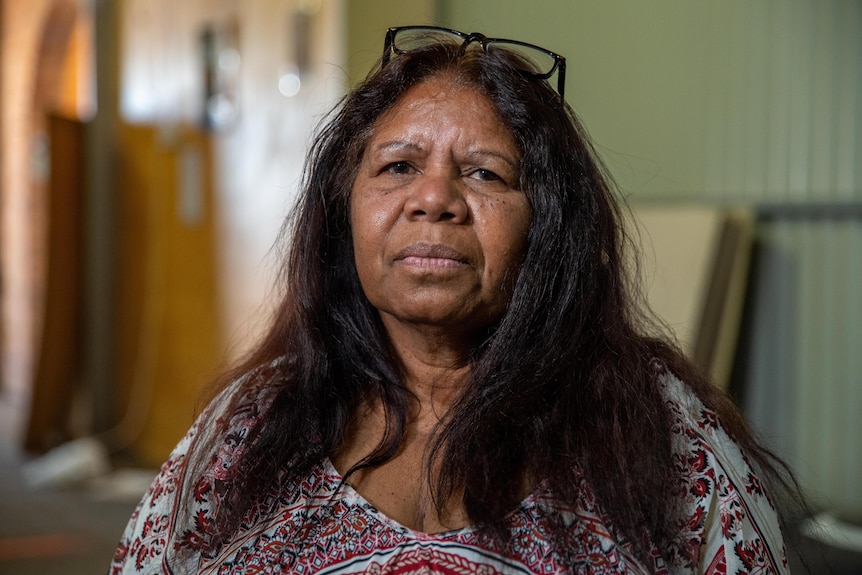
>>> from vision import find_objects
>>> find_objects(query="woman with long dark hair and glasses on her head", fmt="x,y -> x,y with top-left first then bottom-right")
112,27 -> 786,573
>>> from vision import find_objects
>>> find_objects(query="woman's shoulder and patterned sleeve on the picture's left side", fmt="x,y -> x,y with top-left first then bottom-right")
110,366 -> 284,574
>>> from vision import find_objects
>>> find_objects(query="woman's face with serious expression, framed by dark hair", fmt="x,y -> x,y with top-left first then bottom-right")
350,78 -> 531,337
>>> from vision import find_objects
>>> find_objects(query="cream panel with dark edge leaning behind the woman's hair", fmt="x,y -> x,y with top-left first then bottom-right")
628,204 -> 754,389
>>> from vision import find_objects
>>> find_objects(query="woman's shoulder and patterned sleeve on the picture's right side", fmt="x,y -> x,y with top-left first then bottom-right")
662,375 -> 788,573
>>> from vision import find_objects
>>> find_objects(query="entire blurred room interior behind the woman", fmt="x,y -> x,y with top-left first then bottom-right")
0,0 -> 862,573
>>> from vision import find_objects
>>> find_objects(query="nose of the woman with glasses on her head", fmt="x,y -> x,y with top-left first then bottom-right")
404,174 -> 469,224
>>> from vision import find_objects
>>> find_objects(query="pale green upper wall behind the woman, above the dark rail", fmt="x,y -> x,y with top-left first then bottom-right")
438,0 -> 862,202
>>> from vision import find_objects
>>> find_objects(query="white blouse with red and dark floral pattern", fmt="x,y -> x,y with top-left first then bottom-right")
110,377 -> 789,575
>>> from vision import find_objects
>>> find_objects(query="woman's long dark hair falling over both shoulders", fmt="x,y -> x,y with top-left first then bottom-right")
196,44 -> 804,572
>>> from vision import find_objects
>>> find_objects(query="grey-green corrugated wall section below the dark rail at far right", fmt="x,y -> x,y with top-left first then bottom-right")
738,215 -> 862,517
